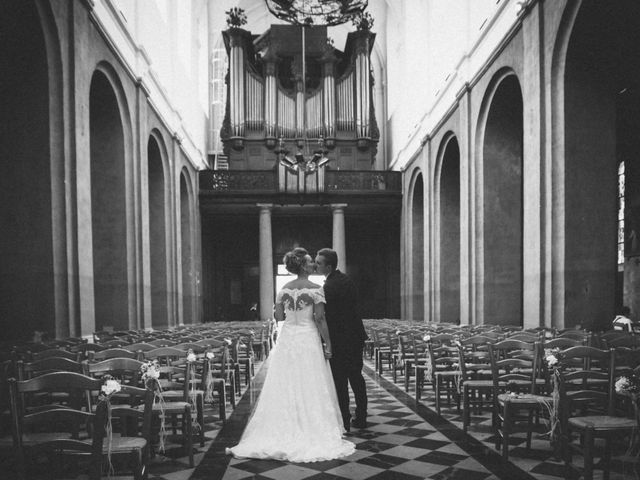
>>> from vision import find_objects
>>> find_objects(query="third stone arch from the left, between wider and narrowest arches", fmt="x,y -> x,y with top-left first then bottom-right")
147,129 -> 171,327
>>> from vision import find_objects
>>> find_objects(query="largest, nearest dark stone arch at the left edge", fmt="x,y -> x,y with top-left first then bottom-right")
0,0 -> 58,340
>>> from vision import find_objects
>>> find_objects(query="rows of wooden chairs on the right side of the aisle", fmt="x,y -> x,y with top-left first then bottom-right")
367,322 -> 640,478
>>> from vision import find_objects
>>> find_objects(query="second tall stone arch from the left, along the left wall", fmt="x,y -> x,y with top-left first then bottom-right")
89,62 -> 135,330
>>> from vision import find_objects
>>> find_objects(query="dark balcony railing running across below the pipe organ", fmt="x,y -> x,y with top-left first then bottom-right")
200,167 -> 402,195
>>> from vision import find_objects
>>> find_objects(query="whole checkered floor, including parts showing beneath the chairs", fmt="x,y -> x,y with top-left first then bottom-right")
0,362 -> 640,480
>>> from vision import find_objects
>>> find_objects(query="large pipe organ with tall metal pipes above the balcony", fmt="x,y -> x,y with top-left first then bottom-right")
221,25 -> 379,170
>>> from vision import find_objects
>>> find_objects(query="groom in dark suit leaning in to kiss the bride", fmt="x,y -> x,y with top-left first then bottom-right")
316,248 -> 367,432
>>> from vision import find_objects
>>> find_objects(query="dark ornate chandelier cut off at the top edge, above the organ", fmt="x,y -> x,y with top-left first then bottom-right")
265,0 -> 369,26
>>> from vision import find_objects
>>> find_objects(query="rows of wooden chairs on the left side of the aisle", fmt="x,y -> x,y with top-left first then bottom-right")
3,324 -> 275,478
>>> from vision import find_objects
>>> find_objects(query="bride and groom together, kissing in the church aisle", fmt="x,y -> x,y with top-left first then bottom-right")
227,248 -> 367,462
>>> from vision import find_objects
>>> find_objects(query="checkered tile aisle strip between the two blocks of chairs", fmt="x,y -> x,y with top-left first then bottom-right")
191,362 -> 545,480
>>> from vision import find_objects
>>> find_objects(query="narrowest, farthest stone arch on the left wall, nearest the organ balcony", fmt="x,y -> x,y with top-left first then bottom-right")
179,167 -> 197,324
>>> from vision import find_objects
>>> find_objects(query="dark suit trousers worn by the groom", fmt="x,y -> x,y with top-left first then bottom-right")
330,345 -> 367,425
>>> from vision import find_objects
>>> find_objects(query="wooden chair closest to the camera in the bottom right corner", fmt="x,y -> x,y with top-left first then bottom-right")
556,346 -> 638,480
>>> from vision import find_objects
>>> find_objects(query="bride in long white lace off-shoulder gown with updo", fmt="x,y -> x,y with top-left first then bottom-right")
227,248 -> 355,462
